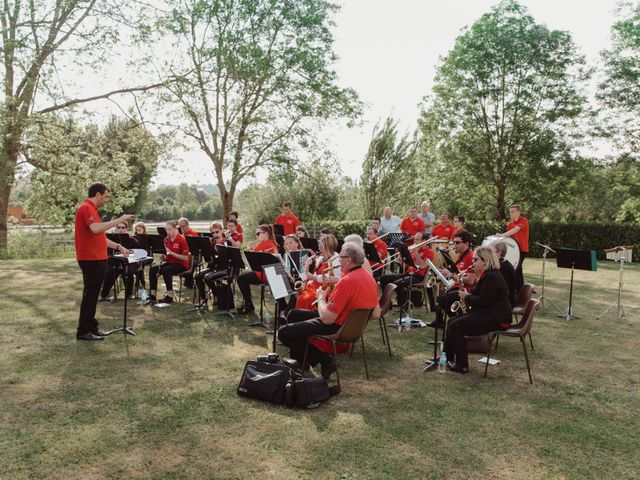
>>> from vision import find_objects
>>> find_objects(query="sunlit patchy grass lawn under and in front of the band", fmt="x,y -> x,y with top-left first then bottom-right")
0,259 -> 640,480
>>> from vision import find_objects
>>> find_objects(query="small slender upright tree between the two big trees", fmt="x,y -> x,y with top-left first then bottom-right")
360,117 -> 419,218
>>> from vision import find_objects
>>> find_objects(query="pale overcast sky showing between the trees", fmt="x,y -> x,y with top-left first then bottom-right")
149,0 -> 616,184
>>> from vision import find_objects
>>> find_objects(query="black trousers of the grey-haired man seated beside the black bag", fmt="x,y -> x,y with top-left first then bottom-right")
278,308 -> 340,366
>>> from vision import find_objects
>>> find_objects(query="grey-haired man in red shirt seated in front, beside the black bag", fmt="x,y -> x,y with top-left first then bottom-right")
278,242 -> 380,379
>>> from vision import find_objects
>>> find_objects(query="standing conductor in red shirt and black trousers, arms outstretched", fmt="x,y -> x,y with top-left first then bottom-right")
74,183 -> 133,340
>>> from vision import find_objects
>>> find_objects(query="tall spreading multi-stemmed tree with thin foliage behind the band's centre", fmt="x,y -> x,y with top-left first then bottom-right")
152,0 -> 360,216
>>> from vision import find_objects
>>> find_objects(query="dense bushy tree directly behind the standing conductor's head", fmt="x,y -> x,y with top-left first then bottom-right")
24,116 -> 163,224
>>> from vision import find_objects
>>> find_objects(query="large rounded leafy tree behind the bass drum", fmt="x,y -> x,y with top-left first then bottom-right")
420,0 -> 589,219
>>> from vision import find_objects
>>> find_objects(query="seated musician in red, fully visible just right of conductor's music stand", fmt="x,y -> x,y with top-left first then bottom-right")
147,220 -> 191,304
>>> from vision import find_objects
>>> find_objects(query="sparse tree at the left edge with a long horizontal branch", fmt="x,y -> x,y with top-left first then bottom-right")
0,0 -> 170,251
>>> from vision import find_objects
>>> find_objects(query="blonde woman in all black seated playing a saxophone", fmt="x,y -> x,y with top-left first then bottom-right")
443,246 -> 511,373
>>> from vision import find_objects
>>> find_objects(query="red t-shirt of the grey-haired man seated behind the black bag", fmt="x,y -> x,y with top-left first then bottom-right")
327,268 -> 378,325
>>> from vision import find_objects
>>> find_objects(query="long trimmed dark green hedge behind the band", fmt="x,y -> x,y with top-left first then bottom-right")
309,220 -> 640,262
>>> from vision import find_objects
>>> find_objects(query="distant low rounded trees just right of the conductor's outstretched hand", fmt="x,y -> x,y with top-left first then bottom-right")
139,183 -> 222,221
